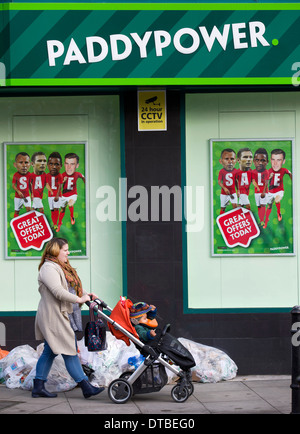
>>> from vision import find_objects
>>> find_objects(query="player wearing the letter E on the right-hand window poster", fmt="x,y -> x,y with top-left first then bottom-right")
264,149 -> 292,228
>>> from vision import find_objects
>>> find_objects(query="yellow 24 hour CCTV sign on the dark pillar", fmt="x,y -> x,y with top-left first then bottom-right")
138,90 -> 167,131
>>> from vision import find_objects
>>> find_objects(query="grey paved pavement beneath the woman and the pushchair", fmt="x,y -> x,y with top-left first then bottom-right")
0,376 -> 291,416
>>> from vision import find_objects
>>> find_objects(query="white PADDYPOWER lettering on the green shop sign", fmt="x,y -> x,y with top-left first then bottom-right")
47,21 -> 270,66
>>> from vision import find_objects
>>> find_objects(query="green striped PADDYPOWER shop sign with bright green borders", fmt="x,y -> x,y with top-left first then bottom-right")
0,3 -> 300,86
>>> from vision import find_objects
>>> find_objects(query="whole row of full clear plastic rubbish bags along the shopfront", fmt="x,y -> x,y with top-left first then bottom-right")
0,332 -> 238,392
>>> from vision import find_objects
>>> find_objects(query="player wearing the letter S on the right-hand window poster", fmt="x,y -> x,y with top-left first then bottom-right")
218,148 -> 237,214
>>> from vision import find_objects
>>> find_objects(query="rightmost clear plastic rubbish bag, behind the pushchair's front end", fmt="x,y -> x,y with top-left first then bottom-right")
168,338 -> 238,383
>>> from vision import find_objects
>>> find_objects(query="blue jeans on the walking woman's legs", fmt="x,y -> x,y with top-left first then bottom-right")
35,341 -> 88,383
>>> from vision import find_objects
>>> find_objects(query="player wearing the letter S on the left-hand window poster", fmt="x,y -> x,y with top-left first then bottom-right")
12,152 -> 31,217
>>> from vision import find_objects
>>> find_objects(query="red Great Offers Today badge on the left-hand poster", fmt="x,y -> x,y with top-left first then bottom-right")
10,211 -> 53,250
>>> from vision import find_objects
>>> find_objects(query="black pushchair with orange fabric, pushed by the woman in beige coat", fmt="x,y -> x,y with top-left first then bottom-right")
86,297 -> 195,404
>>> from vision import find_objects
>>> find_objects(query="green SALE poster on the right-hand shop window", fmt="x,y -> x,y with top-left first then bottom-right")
210,139 -> 295,257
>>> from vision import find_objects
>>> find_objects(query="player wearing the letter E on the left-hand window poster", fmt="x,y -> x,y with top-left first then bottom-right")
56,153 -> 85,232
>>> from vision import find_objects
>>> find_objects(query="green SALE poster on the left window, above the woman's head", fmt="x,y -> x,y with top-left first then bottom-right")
4,142 -> 87,259
